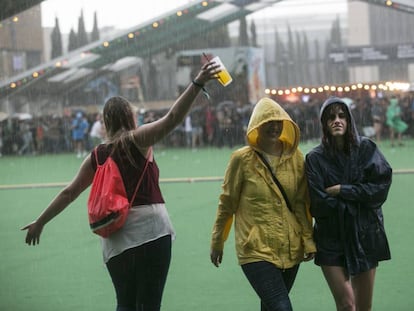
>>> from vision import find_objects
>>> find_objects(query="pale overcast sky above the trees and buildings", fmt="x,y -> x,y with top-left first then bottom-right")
41,0 -> 347,33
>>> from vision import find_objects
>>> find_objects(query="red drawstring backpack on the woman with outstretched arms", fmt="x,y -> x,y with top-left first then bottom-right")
88,147 -> 150,238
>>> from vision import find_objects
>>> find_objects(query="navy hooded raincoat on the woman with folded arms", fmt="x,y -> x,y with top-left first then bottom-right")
306,97 -> 392,275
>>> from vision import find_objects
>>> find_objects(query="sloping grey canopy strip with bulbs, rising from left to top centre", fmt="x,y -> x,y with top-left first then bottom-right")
0,0 -> 280,97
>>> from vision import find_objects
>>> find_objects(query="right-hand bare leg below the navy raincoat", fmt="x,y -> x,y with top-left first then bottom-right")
351,268 -> 376,311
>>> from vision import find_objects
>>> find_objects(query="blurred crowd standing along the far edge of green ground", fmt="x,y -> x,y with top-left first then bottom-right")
0,93 -> 414,158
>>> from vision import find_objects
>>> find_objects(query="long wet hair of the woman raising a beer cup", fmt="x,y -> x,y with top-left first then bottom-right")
103,96 -> 136,166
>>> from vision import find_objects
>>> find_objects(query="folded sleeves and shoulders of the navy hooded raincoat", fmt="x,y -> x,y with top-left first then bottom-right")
306,138 -> 392,218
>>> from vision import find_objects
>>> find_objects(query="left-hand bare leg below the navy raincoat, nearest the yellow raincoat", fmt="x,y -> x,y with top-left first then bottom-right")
322,266 -> 355,311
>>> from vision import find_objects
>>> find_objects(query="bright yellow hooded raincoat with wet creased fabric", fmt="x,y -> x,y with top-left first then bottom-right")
211,98 -> 316,268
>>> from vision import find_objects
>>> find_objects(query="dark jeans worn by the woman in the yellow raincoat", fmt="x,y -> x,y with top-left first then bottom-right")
242,261 -> 299,311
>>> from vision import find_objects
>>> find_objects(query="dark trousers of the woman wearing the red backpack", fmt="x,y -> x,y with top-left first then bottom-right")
106,235 -> 171,311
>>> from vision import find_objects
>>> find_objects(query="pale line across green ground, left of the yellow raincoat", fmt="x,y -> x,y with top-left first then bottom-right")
0,177 -> 225,190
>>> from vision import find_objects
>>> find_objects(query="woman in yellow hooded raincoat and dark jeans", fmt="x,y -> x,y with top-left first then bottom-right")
210,98 -> 316,311
